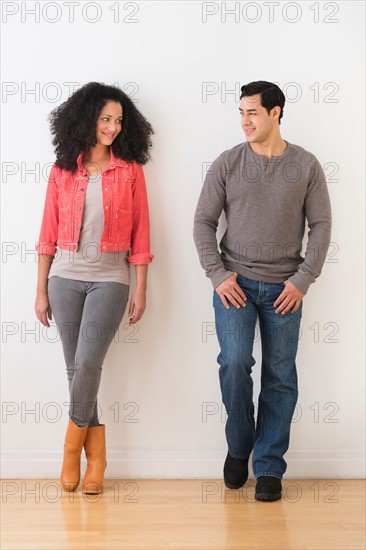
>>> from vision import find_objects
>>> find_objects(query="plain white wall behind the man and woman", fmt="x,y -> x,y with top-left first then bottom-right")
1,1 -> 365,477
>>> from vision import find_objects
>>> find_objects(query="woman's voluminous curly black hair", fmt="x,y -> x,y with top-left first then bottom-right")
48,82 -> 154,172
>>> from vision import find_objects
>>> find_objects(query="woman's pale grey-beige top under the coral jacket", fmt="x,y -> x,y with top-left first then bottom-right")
48,175 -> 130,285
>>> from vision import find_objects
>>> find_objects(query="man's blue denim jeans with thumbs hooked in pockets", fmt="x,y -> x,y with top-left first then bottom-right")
213,275 -> 302,479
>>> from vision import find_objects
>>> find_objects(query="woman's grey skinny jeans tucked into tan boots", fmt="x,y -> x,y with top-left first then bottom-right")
48,275 -> 129,428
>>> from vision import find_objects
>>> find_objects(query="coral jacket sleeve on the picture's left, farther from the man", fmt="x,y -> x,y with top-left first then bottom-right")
36,164 -> 59,256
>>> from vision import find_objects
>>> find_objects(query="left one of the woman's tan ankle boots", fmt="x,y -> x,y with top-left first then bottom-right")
61,418 -> 89,491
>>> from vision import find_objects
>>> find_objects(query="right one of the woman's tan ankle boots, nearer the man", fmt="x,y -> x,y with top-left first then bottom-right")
83,424 -> 107,495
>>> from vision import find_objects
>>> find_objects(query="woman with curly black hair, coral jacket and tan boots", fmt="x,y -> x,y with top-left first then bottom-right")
35,82 -> 154,494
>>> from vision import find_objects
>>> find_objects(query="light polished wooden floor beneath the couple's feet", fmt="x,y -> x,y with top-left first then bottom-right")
0,479 -> 366,550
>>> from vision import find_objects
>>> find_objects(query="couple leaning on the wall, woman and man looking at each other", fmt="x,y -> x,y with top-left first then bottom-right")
35,81 -> 331,501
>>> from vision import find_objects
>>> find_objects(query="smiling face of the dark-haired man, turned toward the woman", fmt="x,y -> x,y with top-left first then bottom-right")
239,94 -> 280,143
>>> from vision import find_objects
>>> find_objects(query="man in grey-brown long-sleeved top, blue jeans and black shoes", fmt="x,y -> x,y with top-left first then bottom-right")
194,81 -> 331,501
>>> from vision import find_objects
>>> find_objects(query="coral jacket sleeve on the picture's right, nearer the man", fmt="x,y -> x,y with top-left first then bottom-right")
128,164 -> 154,265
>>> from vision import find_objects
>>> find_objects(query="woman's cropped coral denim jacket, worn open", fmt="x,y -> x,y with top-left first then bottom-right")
36,148 -> 154,265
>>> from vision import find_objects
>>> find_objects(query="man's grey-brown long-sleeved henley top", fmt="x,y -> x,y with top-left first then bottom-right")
193,142 -> 331,294
